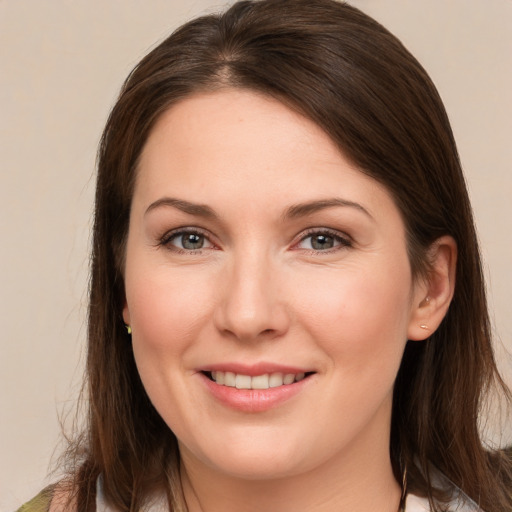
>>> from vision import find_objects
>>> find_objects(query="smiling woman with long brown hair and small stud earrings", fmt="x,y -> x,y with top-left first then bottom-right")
16,0 -> 512,512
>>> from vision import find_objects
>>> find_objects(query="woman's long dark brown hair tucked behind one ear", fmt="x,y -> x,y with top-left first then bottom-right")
69,0 -> 512,512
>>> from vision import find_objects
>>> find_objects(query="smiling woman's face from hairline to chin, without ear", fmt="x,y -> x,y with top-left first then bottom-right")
123,90 -> 424,479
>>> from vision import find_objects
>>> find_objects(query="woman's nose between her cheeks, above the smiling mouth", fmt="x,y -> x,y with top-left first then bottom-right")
214,250 -> 290,341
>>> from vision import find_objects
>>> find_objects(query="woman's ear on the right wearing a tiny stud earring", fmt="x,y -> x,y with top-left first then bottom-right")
408,236 -> 457,340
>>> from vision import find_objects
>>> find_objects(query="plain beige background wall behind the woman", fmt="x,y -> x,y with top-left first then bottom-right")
0,0 -> 512,511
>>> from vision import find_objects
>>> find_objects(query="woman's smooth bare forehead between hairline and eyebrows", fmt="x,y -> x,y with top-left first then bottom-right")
134,89 -> 396,220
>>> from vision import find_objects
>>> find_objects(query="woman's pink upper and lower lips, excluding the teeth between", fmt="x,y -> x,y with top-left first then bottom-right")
196,363 -> 312,413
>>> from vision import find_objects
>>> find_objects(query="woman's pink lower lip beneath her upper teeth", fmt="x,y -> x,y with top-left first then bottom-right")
198,373 -> 311,412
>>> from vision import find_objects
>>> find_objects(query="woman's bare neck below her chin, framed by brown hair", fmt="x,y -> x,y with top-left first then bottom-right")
182,412 -> 401,512
